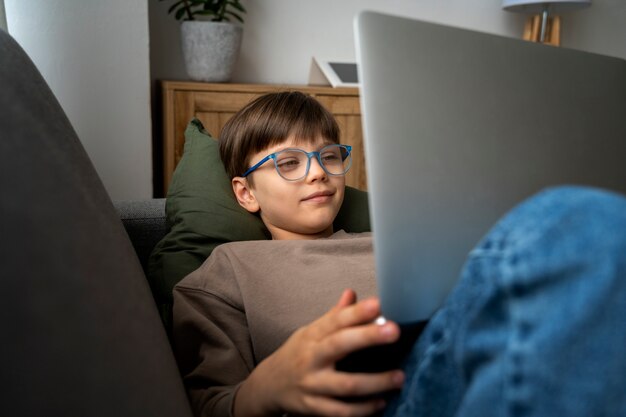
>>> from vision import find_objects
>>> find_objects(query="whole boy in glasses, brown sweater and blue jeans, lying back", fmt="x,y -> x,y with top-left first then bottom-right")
174,93 -> 626,417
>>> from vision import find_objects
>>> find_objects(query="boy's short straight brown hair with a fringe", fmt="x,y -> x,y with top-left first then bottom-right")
219,91 -> 339,178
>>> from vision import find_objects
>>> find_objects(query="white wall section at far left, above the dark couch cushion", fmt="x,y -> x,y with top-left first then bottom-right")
4,0 -> 151,200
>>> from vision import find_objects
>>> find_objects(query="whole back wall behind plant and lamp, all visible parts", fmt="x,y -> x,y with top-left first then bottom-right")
150,0 -> 626,84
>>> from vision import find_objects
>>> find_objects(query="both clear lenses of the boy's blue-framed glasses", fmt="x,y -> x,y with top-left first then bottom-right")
275,146 -> 350,180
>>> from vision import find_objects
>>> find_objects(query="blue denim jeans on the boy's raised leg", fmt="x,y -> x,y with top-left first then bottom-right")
385,187 -> 626,417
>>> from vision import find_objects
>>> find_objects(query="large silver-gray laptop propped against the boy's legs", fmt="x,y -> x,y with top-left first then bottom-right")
355,12 -> 626,325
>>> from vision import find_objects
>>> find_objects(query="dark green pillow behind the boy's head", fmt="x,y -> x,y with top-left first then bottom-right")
148,119 -> 370,328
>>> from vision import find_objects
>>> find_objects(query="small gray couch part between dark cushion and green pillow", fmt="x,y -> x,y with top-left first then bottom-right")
113,198 -> 169,271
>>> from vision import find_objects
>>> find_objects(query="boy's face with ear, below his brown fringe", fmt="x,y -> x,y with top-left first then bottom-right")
232,137 -> 345,239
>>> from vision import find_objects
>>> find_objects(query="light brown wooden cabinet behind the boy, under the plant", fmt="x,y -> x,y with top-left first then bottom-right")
161,81 -> 366,193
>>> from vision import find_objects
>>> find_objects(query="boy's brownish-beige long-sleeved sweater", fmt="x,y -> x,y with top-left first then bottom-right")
173,231 -> 376,417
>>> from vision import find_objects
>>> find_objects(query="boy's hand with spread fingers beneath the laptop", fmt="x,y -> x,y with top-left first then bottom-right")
233,290 -> 404,417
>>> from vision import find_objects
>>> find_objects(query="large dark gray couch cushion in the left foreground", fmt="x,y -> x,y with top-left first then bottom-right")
0,30 -> 190,417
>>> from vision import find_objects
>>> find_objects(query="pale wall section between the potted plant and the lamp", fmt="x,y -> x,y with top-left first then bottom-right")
235,0 -> 521,84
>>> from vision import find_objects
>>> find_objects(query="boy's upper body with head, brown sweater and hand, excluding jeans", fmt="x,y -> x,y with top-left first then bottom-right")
174,92 -> 404,416
